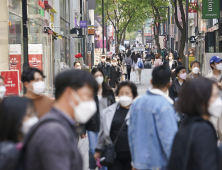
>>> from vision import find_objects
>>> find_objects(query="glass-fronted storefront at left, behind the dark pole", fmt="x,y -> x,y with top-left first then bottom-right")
8,0 -> 56,96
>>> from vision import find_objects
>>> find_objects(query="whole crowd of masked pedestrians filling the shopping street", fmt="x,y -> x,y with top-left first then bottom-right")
0,52 -> 222,170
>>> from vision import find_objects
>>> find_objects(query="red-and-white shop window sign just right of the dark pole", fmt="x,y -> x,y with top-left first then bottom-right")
28,44 -> 42,70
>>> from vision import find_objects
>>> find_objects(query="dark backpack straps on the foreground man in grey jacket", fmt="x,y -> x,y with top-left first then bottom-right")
17,118 -> 74,170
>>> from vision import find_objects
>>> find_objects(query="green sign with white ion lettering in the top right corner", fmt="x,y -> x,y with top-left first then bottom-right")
202,0 -> 220,19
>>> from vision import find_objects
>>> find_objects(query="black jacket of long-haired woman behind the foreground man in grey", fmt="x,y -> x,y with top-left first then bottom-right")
83,94 -> 115,134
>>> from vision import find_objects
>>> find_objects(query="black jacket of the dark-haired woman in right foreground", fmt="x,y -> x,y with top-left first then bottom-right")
168,116 -> 220,170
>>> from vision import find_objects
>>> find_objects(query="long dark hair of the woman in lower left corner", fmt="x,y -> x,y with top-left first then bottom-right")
0,96 -> 33,142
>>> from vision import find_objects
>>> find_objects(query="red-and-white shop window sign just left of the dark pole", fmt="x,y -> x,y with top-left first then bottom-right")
9,44 -> 22,79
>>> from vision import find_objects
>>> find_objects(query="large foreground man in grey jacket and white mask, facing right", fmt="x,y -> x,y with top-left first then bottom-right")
24,69 -> 98,170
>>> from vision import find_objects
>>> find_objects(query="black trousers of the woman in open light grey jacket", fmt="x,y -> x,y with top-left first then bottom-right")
108,151 -> 132,170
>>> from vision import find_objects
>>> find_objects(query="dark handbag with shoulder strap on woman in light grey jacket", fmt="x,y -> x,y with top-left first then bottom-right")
100,119 -> 128,167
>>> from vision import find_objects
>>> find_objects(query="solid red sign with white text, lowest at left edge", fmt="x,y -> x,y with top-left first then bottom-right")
0,70 -> 20,96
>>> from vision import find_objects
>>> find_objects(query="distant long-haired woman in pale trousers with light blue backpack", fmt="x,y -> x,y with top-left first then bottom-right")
133,53 -> 144,83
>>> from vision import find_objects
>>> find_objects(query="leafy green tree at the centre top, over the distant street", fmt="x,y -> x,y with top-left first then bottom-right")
96,0 -> 149,52
